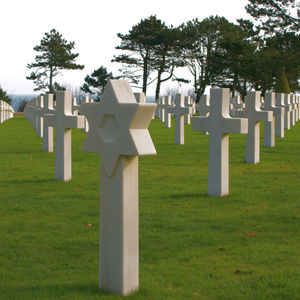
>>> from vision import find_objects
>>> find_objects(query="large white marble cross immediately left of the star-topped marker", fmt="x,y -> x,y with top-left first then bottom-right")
44,91 -> 84,181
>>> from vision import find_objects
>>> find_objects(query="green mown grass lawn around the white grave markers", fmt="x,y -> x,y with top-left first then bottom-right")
0,117 -> 300,300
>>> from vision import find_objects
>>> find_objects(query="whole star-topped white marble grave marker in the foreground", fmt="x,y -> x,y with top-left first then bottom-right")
82,80 -> 156,295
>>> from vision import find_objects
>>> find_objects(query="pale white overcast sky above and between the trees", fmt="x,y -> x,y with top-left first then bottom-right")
0,0 -> 250,95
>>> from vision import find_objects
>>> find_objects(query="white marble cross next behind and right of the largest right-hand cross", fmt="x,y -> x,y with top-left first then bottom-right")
235,92 -> 273,164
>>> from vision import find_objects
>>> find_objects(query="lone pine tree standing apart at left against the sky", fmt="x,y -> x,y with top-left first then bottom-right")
26,29 -> 84,93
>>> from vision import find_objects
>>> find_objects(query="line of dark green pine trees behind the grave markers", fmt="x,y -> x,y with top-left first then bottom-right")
8,0 -> 300,101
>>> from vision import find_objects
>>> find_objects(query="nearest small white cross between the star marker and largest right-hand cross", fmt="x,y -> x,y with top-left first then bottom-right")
168,94 -> 191,145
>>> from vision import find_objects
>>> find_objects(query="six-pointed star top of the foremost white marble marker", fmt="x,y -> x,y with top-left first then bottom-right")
81,80 -> 156,176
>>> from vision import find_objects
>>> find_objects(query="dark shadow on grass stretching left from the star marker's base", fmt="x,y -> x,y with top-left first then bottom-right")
0,283 -> 122,299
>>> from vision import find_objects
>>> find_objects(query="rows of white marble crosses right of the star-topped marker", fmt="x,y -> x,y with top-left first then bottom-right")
156,89 -> 300,196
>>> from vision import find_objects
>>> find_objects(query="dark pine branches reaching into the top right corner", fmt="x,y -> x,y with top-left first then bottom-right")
245,0 -> 300,33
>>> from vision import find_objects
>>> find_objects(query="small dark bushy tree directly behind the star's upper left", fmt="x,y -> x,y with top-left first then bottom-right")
80,66 -> 117,101
